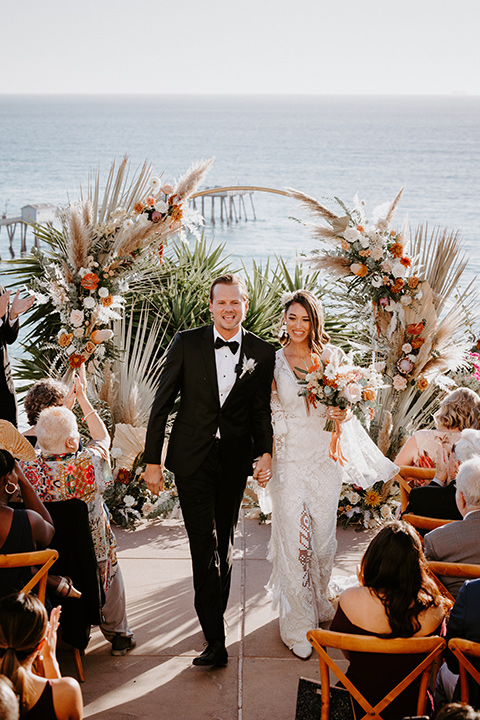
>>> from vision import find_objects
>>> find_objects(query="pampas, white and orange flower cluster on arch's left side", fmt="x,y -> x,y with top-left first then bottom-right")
28,158 -> 212,368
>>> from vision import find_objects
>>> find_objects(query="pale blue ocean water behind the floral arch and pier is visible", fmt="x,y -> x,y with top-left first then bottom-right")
0,95 -> 480,276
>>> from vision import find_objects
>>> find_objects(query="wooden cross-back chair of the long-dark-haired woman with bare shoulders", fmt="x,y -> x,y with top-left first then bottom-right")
307,630 -> 446,720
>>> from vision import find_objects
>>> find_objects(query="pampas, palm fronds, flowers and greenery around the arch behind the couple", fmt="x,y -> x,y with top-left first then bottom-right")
5,171 -> 477,526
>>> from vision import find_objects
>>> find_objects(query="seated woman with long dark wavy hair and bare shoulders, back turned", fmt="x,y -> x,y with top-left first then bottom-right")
330,521 -> 448,720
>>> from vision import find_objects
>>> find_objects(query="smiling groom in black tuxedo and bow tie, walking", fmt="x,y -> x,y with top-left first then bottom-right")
144,275 -> 275,666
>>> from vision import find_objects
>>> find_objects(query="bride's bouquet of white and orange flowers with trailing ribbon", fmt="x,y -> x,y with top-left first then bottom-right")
299,345 -> 383,465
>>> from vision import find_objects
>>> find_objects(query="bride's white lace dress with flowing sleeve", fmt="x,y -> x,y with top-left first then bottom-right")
261,350 -> 396,648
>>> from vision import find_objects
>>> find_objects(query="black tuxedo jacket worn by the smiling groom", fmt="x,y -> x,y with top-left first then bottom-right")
144,325 -> 275,477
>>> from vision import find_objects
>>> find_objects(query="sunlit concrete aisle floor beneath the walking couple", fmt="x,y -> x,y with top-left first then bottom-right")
69,517 -> 374,720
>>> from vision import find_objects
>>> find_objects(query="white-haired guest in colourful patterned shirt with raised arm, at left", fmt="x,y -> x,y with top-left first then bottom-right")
23,370 -> 135,655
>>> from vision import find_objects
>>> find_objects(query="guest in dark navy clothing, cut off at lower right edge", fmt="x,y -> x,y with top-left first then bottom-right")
435,579 -> 480,709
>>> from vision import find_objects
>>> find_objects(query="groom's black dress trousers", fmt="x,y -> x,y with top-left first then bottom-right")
175,440 -> 247,642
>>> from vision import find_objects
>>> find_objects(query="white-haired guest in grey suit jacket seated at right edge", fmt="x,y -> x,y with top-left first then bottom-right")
425,456 -> 480,597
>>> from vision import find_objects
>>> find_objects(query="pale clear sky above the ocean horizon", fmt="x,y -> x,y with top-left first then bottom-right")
0,0 -> 480,95
